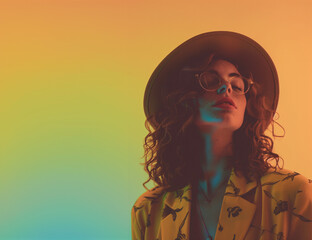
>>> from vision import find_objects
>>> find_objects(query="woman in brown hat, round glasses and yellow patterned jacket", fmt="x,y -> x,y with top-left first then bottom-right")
132,31 -> 312,240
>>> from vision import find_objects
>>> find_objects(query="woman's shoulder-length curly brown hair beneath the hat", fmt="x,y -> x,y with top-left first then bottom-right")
141,54 -> 285,190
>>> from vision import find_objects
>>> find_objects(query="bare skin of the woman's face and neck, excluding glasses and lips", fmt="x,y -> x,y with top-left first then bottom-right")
195,60 -> 247,195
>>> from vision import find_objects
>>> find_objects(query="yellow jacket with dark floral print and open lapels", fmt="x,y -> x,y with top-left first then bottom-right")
131,169 -> 312,240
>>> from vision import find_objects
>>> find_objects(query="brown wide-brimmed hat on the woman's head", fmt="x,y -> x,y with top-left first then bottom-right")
144,31 -> 279,127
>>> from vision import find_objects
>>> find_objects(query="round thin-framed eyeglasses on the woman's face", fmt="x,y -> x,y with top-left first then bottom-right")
195,72 -> 254,95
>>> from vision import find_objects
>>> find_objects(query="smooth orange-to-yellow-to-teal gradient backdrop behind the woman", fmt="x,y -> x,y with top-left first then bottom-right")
0,0 -> 312,240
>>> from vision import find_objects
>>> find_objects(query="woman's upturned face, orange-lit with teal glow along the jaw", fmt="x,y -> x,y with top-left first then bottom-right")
195,60 -> 246,131
